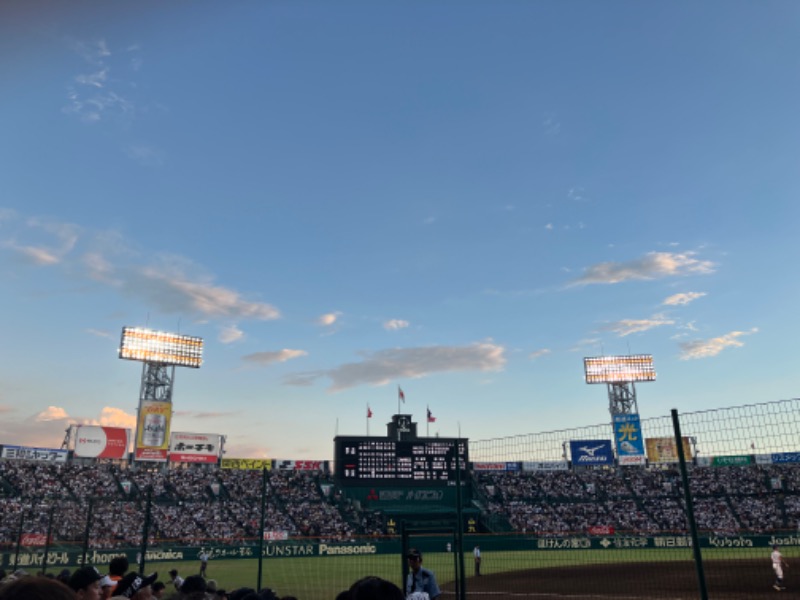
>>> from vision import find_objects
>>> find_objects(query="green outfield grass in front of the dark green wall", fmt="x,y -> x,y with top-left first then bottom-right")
145,548 -> 784,600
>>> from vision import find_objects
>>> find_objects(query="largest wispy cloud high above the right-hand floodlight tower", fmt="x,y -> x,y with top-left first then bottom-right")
571,252 -> 716,286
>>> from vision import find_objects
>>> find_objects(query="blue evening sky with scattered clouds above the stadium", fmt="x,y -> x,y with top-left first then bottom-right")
0,0 -> 800,458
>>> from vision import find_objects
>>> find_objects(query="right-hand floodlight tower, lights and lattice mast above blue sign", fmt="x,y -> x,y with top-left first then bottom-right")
583,354 -> 656,419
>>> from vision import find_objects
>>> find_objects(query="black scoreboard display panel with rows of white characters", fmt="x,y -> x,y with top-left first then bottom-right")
334,437 -> 468,486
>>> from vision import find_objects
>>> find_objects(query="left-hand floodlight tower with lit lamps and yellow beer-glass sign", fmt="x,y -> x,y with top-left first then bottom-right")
119,327 -> 203,460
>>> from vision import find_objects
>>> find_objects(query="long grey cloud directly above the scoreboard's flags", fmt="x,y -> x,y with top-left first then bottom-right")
285,342 -> 506,392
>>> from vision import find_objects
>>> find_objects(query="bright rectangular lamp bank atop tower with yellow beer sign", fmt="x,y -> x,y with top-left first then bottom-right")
119,327 -> 203,369
